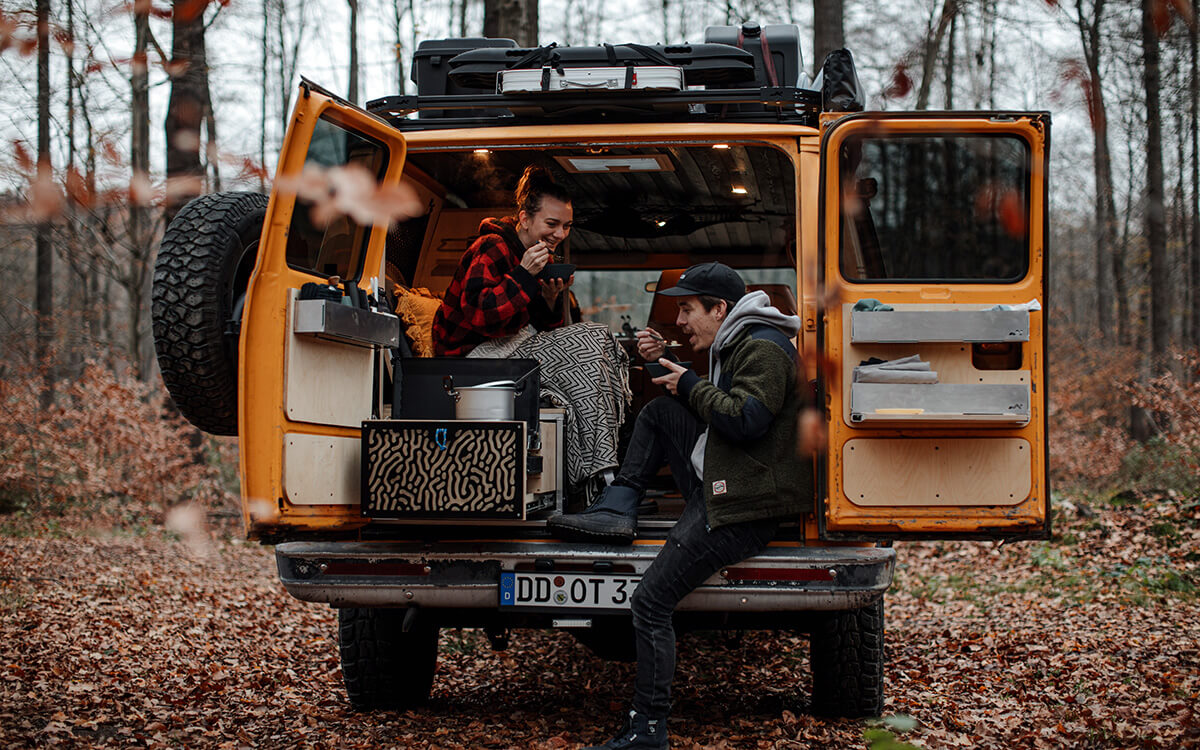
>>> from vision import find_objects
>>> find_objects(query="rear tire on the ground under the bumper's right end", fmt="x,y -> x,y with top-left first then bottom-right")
809,596 -> 883,718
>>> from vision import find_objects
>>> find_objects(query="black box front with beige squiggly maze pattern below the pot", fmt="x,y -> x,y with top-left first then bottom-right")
362,420 -> 524,518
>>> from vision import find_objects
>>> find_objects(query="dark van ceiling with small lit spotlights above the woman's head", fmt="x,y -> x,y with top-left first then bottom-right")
409,144 -> 796,265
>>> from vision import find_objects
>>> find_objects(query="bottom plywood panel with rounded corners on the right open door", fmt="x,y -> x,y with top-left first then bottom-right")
841,438 -> 1032,506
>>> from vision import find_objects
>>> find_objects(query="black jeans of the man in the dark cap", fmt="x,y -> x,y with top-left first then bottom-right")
614,398 -> 779,719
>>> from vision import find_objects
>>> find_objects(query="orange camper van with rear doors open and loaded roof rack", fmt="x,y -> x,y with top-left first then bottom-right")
154,25 -> 1050,715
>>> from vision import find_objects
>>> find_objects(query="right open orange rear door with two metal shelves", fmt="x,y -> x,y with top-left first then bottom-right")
818,113 -> 1050,539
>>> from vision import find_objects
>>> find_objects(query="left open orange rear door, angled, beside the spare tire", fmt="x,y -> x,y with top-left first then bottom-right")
238,82 -> 404,536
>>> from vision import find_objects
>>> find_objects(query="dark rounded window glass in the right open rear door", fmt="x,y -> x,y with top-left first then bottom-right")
839,136 -> 1030,282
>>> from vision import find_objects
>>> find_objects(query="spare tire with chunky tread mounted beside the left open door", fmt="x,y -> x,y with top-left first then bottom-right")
150,192 -> 268,434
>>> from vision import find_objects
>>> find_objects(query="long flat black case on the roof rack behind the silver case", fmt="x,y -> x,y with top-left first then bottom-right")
450,44 -> 754,91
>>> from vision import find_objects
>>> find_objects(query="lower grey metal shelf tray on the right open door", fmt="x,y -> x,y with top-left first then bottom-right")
850,383 -> 1030,427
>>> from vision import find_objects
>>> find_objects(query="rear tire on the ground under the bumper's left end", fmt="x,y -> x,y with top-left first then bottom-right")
337,608 -> 438,710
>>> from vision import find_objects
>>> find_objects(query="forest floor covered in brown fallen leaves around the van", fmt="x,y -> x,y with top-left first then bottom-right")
0,493 -> 1200,749
